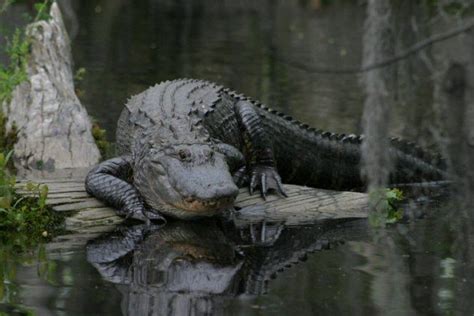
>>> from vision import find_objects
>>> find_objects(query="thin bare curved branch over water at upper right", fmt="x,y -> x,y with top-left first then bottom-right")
277,21 -> 474,74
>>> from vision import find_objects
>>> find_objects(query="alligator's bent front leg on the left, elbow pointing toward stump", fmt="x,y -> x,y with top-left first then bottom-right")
86,156 -> 166,223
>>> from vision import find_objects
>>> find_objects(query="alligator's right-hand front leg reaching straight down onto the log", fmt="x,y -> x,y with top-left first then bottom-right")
235,100 -> 287,199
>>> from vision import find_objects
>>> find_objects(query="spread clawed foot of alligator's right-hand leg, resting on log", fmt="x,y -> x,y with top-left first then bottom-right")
249,165 -> 288,200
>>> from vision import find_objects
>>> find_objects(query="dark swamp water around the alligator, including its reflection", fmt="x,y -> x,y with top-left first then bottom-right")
0,0 -> 474,315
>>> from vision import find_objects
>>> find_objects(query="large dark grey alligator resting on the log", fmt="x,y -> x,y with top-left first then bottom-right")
86,79 -> 446,222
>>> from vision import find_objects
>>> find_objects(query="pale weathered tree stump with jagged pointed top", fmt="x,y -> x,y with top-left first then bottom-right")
6,3 -> 100,169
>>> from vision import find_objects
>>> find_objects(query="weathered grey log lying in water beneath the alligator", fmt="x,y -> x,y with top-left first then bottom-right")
16,168 -> 368,238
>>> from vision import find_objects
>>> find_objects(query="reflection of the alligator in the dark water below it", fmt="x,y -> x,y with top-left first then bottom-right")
87,220 -> 367,315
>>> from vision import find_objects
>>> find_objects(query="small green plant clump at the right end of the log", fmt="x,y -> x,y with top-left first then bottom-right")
369,189 -> 404,228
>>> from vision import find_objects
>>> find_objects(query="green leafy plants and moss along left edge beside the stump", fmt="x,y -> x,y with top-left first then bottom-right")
0,11 -> 62,296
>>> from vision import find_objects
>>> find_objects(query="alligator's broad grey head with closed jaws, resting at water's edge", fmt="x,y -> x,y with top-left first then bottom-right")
134,144 -> 238,219
